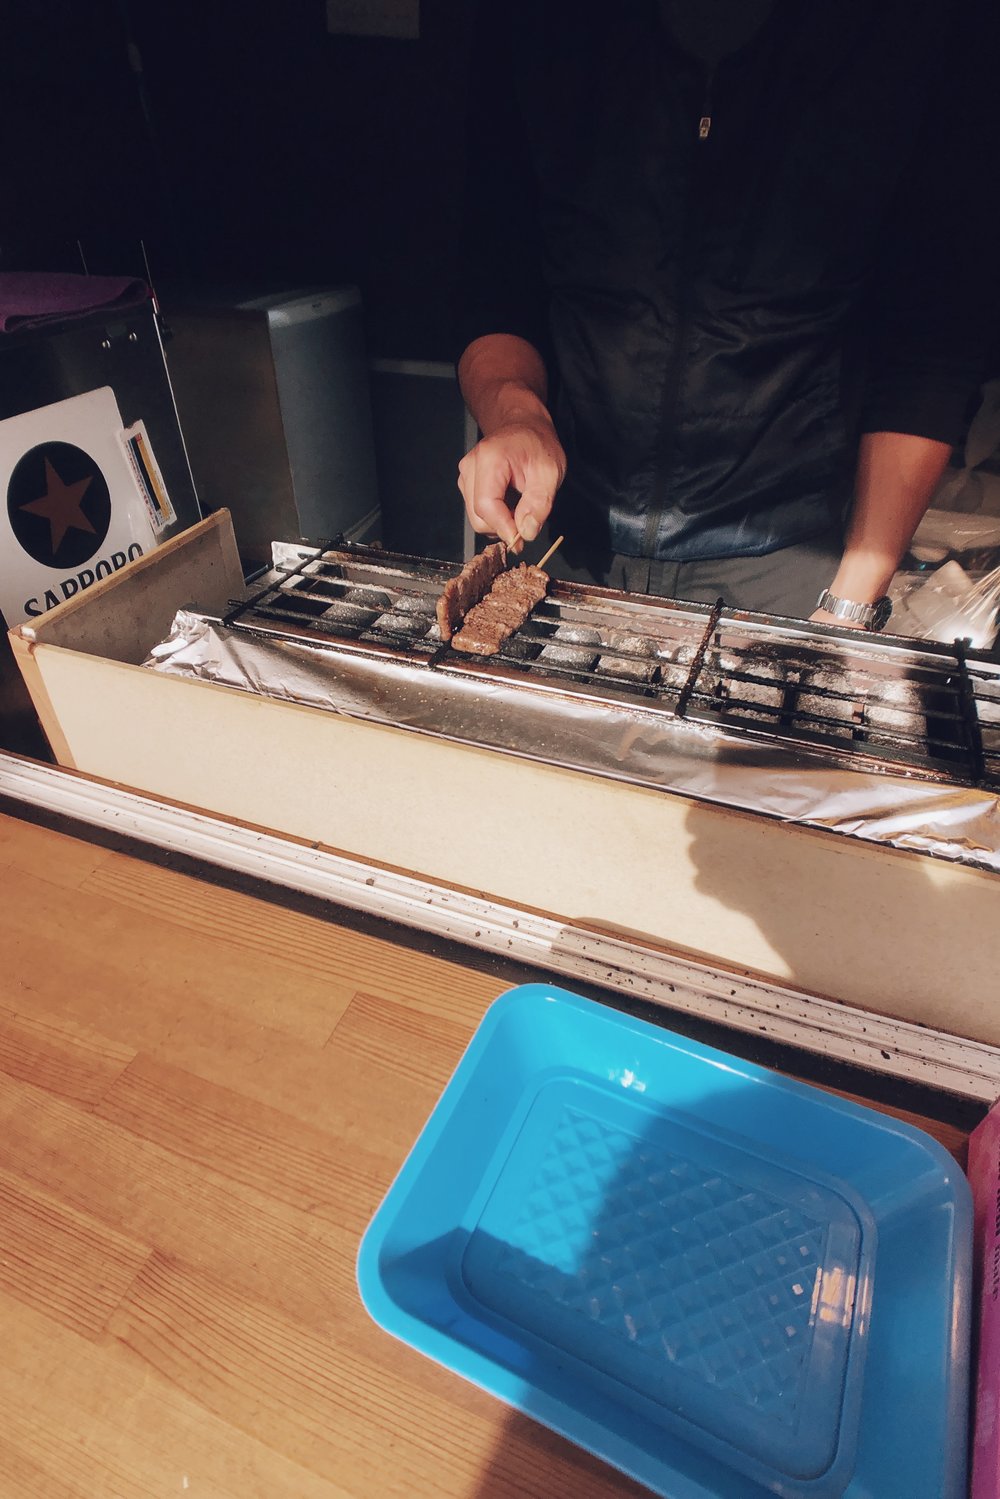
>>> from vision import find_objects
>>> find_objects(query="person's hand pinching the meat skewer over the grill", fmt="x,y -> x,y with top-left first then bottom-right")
459,417 -> 567,541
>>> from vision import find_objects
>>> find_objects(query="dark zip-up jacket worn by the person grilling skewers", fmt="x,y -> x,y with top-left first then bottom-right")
460,0 -> 997,559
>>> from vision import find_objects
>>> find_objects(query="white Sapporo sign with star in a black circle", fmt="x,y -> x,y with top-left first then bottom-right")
0,385 -> 156,625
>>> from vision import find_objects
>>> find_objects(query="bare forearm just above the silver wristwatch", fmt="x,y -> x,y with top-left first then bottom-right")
831,432 -> 951,603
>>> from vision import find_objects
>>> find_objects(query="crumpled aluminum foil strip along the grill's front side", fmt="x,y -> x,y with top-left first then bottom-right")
144,610 -> 1000,871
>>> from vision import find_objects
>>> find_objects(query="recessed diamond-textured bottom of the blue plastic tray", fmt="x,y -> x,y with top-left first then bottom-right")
460,1078 -> 874,1493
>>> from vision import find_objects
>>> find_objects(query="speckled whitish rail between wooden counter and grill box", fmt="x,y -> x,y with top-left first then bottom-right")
0,751 -> 1000,1103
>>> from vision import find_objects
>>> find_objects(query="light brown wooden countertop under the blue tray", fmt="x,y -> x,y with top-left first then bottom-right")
0,817 -> 961,1499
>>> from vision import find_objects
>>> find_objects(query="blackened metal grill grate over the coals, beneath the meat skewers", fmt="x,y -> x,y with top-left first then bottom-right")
223,546 -> 1000,790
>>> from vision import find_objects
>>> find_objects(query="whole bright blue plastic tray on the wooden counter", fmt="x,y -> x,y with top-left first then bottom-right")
358,985 -> 972,1499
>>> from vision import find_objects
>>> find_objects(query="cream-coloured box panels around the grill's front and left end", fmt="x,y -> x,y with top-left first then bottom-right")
12,511 -> 1000,1043
